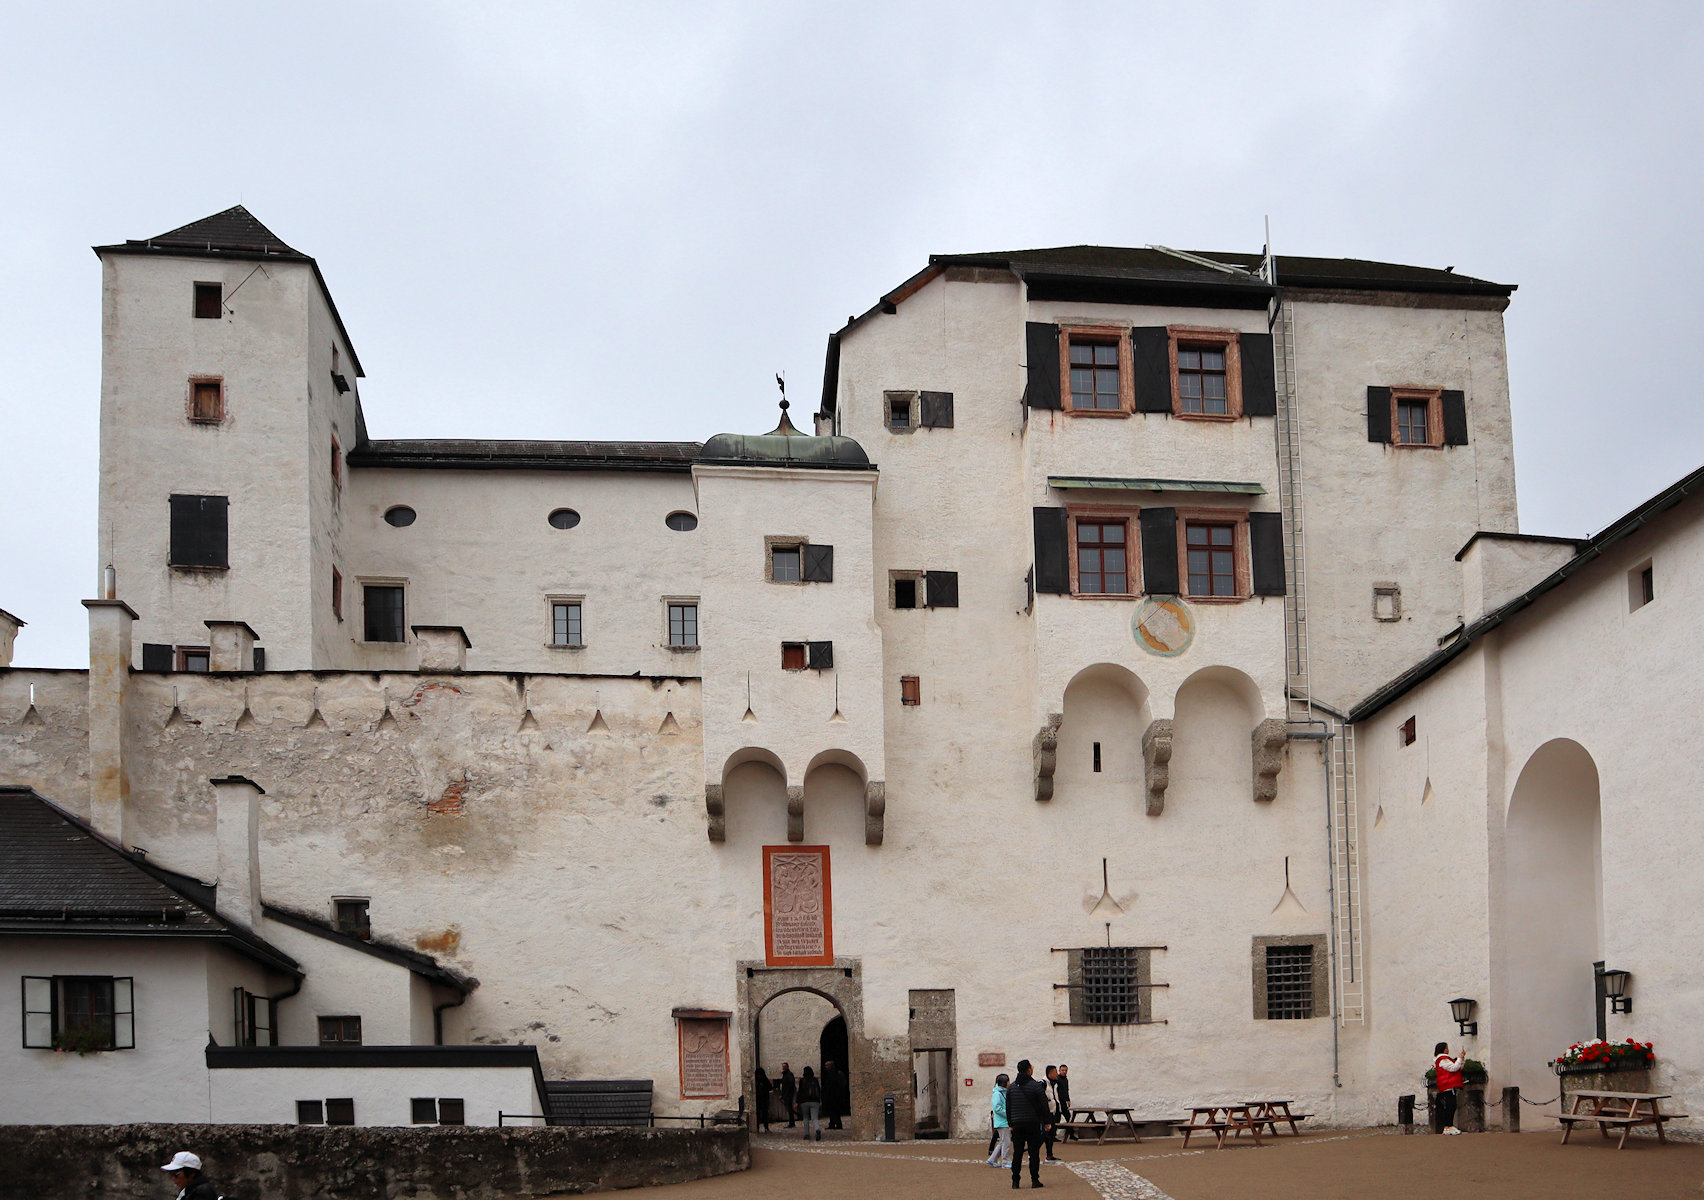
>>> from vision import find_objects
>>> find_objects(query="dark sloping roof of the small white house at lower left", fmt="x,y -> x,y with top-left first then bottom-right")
0,788 -> 302,975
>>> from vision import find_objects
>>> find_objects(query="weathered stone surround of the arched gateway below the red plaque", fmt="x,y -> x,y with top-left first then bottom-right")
734,958 -> 912,1142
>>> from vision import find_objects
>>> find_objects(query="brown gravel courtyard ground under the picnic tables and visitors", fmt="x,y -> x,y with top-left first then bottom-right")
552,1123 -> 1704,1200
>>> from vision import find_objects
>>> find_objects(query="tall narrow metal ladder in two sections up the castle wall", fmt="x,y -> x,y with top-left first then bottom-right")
1261,250 -> 1367,1024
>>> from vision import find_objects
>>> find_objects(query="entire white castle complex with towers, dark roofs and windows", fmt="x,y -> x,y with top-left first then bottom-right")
0,208 -> 1704,1135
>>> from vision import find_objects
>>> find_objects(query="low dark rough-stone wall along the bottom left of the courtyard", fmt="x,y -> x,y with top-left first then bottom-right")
0,1125 -> 751,1200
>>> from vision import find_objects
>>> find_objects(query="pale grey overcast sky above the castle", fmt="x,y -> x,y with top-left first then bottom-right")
0,0 -> 1704,666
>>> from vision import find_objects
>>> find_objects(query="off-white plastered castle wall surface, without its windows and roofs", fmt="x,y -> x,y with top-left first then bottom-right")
0,215 -> 1704,1134
